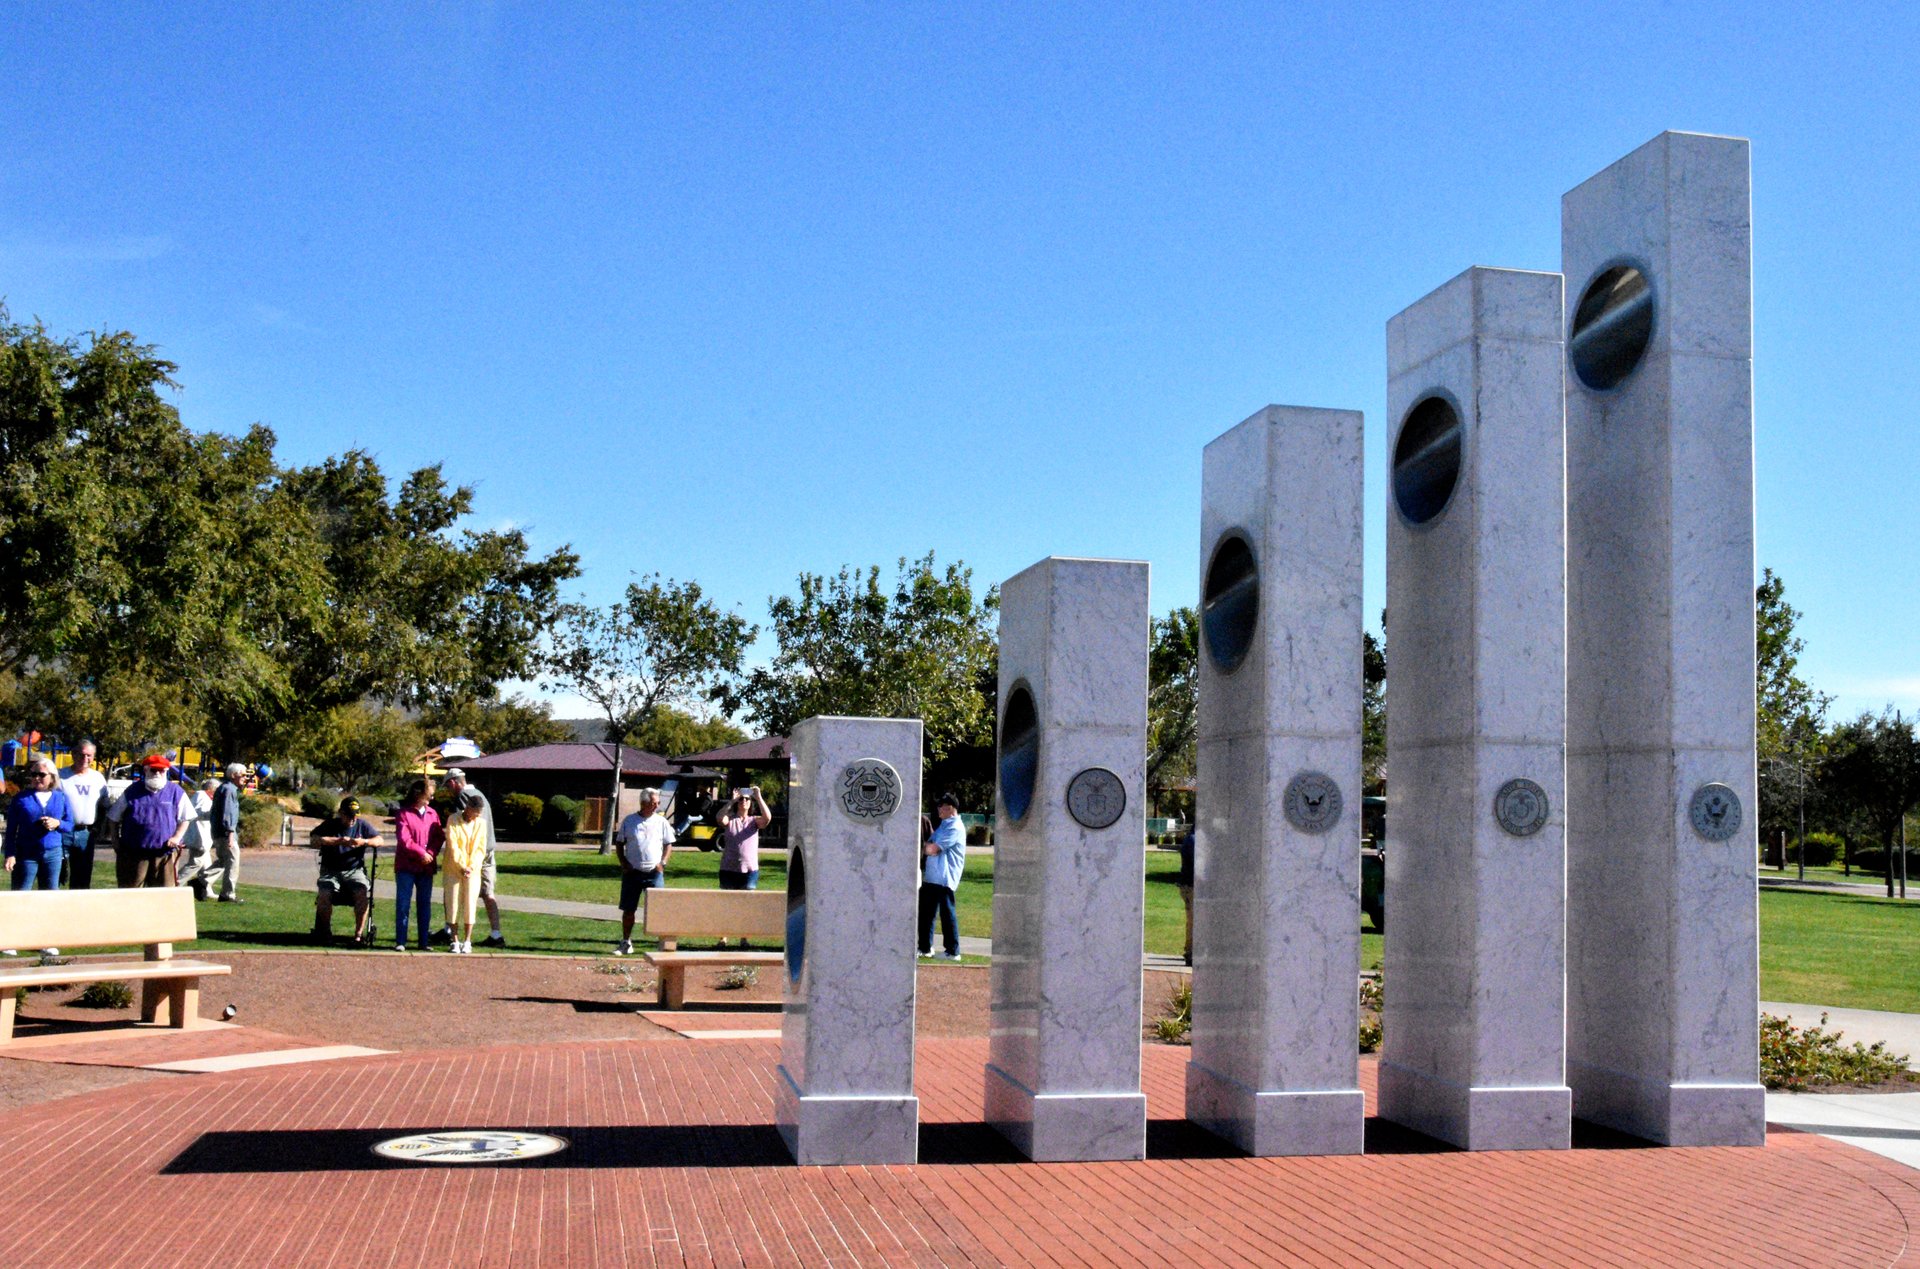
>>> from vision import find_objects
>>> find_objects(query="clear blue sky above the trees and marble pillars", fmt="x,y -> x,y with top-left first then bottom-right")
0,4 -> 1920,712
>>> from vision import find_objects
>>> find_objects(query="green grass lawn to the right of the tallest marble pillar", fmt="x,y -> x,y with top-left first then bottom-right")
1761,886 -> 1920,1014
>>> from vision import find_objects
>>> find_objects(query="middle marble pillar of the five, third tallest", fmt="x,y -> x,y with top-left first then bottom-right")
1187,405 -> 1367,1154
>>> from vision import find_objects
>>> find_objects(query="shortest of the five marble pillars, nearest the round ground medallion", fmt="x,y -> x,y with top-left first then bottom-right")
774,718 -> 920,1163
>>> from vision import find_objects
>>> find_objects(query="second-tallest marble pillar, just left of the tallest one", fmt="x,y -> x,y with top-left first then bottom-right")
1380,269 -> 1572,1150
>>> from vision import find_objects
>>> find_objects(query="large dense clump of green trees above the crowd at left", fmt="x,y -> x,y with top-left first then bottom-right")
0,309 -> 578,756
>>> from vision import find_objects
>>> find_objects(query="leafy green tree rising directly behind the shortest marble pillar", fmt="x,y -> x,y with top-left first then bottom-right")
724,551 -> 1000,760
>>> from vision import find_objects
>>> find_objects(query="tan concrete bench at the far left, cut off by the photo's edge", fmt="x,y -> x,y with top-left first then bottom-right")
0,887 -> 232,1044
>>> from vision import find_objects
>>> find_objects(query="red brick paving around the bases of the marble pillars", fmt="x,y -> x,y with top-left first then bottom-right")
0,1039 -> 1920,1269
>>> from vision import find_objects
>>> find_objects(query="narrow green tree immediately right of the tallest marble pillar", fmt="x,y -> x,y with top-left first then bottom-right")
1753,568 -> 1834,864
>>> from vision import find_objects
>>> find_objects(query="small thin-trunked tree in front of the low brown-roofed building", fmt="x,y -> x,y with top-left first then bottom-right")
541,574 -> 756,854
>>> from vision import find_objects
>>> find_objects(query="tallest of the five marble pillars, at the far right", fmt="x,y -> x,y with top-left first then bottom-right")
1561,132 -> 1766,1146
